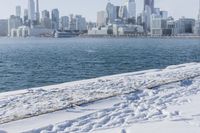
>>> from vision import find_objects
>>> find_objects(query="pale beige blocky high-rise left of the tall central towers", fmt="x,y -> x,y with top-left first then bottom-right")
97,11 -> 106,27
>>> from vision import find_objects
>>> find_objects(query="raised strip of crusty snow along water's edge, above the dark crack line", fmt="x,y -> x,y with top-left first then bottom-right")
0,63 -> 200,124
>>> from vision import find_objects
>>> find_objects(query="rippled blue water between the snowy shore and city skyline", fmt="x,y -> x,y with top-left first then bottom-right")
0,38 -> 200,92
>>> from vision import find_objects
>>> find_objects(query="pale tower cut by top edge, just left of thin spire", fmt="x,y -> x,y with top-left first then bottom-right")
28,0 -> 36,22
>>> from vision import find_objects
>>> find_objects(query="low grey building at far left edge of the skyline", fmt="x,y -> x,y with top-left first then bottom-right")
0,19 -> 8,36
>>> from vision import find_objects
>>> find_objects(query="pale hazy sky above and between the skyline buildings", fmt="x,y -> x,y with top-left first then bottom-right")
0,0 -> 199,21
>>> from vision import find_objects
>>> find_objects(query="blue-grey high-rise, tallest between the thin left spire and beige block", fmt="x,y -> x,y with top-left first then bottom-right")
51,9 -> 59,30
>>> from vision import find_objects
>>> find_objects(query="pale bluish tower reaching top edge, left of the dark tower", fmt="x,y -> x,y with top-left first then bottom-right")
125,0 -> 136,18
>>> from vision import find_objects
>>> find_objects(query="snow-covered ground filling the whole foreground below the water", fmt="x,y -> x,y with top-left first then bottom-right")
0,63 -> 200,133
